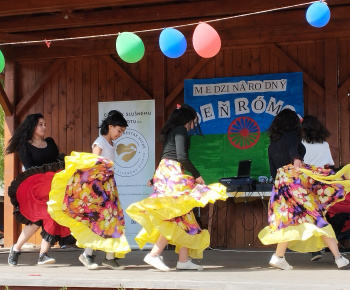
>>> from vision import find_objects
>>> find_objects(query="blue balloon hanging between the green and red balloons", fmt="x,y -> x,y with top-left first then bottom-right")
159,28 -> 187,58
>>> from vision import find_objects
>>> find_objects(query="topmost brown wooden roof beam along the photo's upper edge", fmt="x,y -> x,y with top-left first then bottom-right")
0,0 -> 320,32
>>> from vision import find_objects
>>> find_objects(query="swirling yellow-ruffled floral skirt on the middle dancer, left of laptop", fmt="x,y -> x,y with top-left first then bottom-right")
126,159 -> 227,259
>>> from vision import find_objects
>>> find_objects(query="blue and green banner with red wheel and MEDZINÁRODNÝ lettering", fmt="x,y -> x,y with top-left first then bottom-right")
184,72 -> 304,183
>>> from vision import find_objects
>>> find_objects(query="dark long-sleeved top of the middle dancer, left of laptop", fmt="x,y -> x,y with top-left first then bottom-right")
162,125 -> 201,178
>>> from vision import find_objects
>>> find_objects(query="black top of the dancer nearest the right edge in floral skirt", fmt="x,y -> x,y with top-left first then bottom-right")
268,131 -> 306,179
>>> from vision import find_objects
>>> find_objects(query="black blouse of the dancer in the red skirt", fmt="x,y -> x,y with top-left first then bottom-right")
19,137 -> 59,169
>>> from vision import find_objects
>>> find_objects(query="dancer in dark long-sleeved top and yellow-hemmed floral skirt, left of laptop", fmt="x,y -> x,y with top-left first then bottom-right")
126,104 -> 227,271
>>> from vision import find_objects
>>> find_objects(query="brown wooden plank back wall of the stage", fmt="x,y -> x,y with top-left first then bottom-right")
5,39 -> 350,247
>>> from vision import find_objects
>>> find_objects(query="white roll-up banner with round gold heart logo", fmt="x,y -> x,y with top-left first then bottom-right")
98,100 -> 155,249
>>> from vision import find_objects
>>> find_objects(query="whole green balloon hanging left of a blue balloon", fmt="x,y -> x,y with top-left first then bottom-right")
116,32 -> 145,63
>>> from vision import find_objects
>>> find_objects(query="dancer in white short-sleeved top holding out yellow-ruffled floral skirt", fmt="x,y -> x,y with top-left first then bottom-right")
48,110 -> 130,270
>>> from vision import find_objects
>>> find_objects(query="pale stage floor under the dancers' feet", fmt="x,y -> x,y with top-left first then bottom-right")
0,248 -> 350,290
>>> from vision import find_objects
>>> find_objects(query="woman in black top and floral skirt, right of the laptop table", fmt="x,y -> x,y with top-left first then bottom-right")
259,109 -> 350,270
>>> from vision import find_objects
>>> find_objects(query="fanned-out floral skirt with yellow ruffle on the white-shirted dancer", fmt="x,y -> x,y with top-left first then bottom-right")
48,152 -> 130,258
